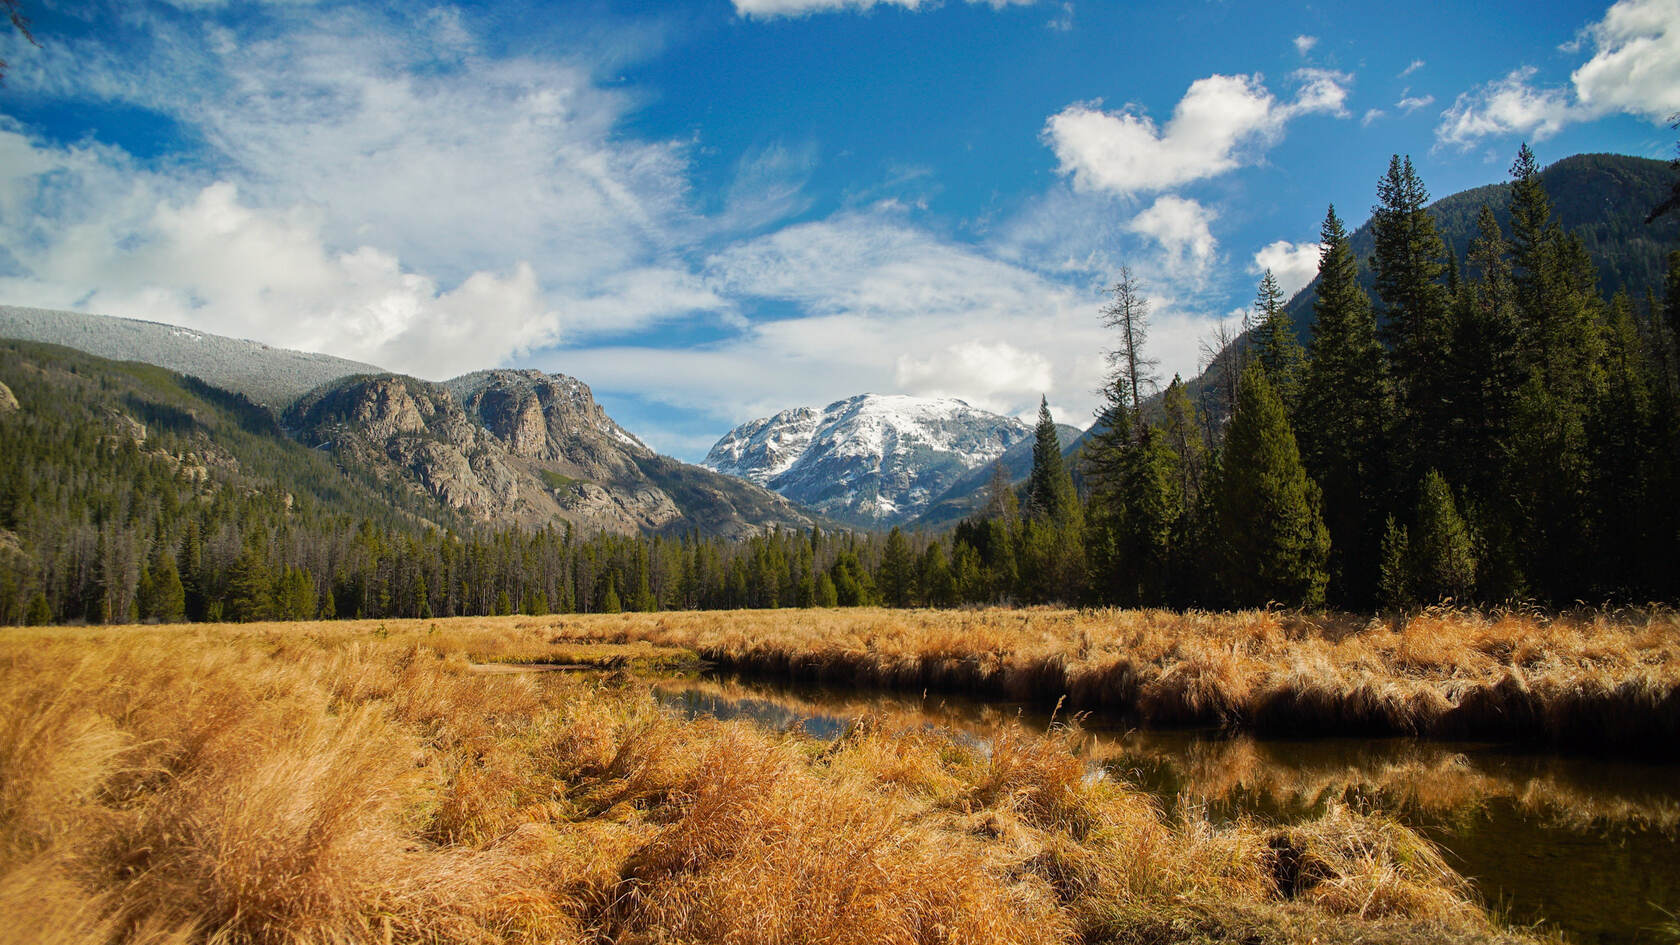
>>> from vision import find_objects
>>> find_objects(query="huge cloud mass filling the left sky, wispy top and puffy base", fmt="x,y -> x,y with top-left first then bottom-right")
0,8 -> 715,377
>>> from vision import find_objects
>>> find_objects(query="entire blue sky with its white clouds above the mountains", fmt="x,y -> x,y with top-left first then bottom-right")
0,0 -> 1680,459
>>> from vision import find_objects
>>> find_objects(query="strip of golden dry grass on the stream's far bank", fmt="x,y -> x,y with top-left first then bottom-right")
543,609 -> 1680,757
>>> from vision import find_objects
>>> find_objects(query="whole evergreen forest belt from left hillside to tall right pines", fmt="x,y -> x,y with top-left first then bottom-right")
0,148 -> 1680,624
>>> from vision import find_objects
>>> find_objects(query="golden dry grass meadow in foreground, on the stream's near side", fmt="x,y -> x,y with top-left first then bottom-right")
0,614 -> 1559,945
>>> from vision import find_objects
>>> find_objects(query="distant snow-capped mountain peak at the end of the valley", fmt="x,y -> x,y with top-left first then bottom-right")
701,393 -> 1032,526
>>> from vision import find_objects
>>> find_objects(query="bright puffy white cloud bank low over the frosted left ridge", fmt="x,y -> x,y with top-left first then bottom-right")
0,150 -> 559,378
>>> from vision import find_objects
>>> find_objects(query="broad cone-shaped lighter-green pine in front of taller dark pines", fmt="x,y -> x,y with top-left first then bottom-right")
1216,365 -> 1331,607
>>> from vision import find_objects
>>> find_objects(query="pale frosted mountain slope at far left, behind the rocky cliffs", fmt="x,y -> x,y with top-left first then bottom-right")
0,306 -> 381,403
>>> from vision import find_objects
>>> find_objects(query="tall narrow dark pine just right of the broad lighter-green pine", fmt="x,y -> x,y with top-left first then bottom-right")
1297,207 -> 1394,605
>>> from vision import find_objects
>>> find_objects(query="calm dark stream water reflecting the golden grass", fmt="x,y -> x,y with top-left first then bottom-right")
655,678 -> 1680,943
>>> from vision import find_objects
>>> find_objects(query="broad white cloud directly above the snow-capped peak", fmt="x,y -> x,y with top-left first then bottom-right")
551,205 -> 1128,424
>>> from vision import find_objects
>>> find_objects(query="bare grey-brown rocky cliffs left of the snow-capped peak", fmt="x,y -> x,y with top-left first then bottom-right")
286,370 -> 810,536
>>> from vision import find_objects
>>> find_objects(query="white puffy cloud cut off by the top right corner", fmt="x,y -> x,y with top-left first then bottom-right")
1435,0 -> 1680,148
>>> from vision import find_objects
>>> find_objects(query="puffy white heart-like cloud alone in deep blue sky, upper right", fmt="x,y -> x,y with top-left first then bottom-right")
1043,69 -> 1349,195
